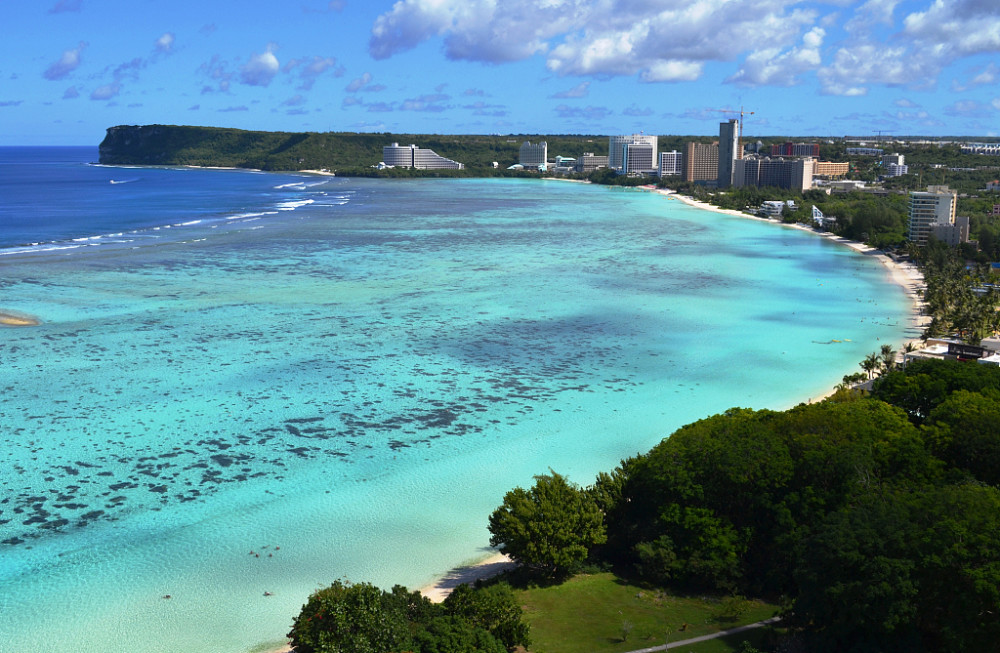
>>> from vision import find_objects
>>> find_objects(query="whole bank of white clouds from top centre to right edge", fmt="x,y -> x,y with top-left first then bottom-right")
369,0 -> 1000,95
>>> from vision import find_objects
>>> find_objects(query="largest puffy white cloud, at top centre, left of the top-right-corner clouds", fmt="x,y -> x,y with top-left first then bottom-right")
369,0 -> 817,82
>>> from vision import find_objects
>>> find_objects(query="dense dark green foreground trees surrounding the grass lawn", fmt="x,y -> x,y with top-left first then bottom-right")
289,360 -> 1000,653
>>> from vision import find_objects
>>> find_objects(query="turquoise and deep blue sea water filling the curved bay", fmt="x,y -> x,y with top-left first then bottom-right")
0,148 -> 911,653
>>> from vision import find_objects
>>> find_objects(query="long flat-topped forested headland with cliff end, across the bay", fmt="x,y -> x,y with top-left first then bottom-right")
100,125 -> 608,172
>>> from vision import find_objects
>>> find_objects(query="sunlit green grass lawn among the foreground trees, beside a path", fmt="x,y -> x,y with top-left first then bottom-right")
517,573 -> 778,653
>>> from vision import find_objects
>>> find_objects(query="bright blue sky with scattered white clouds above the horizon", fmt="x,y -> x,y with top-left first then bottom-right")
0,0 -> 1000,145
